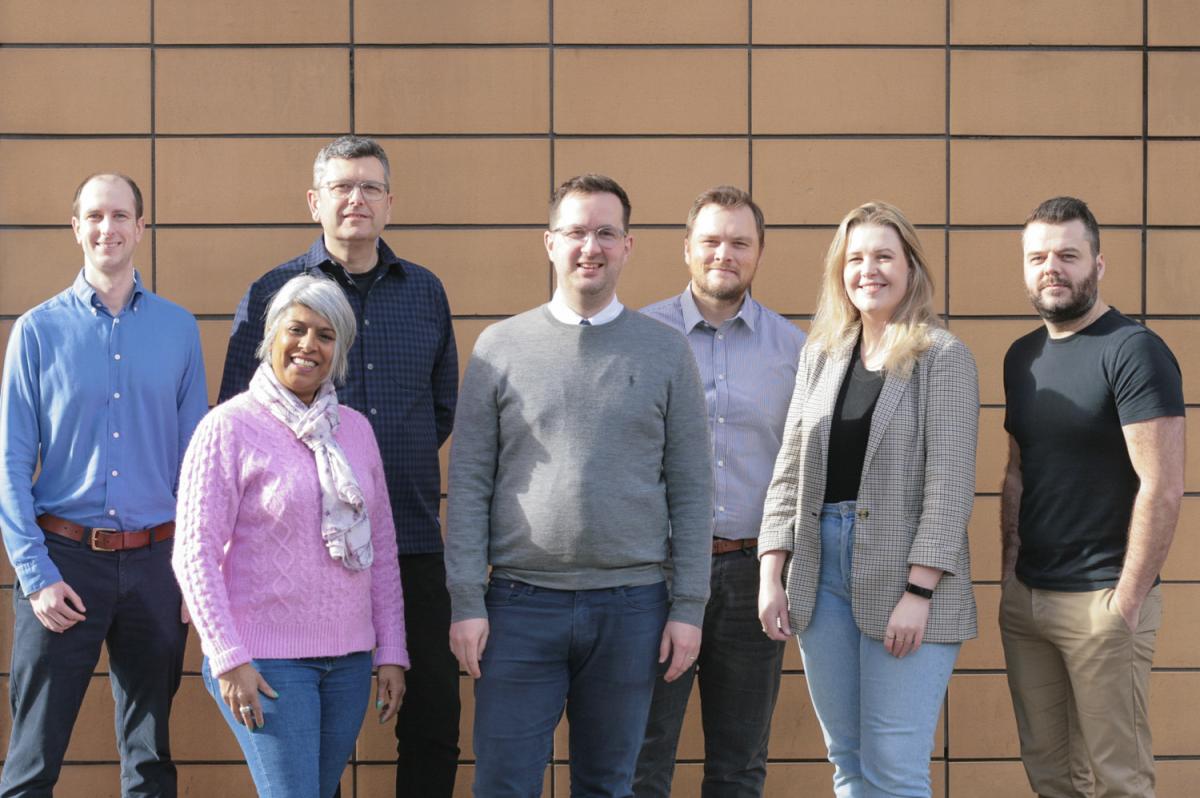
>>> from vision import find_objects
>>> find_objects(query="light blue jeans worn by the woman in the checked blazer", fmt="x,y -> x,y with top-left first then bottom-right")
798,502 -> 960,798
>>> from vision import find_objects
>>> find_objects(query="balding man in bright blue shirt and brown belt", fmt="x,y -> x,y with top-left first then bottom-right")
0,174 -> 208,797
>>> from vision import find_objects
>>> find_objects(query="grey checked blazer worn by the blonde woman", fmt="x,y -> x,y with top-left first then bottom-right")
758,329 -> 979,643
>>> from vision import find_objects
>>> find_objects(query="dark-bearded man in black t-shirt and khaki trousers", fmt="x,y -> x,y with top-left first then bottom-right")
1000,197 -> 1184,798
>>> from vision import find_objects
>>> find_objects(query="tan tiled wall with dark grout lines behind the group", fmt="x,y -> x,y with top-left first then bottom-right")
0,0 -> 1200,798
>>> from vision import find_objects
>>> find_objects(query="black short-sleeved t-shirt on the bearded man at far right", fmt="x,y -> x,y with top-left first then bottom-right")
1004,308 -> 1183,590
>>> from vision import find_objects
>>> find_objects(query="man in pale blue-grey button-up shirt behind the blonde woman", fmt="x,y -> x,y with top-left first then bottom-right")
634,186 -> 804,798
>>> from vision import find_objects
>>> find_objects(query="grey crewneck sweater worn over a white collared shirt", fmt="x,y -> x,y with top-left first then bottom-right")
445,306 -> 713,626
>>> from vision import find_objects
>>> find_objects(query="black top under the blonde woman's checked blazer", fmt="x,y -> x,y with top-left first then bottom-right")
824,340 -> 883,503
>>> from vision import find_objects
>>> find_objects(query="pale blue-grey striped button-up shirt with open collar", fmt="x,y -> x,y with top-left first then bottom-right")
642,284 -> 804,540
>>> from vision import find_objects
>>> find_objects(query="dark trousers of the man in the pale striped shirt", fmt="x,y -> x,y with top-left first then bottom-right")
634,550 -> 786,798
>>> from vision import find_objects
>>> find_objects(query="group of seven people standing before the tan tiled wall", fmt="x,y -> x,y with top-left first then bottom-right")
0,136 -> 1184,798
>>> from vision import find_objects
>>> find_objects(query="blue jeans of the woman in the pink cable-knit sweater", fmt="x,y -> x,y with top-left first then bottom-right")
200,652 -> 371,798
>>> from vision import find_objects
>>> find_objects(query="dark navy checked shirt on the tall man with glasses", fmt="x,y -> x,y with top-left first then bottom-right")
217,236 -> 458,554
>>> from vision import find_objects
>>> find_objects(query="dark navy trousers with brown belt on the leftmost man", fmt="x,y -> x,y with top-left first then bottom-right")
0,535 -> 187,798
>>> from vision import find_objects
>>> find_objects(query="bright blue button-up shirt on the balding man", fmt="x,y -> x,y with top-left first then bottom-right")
0,270 -> 209,595
